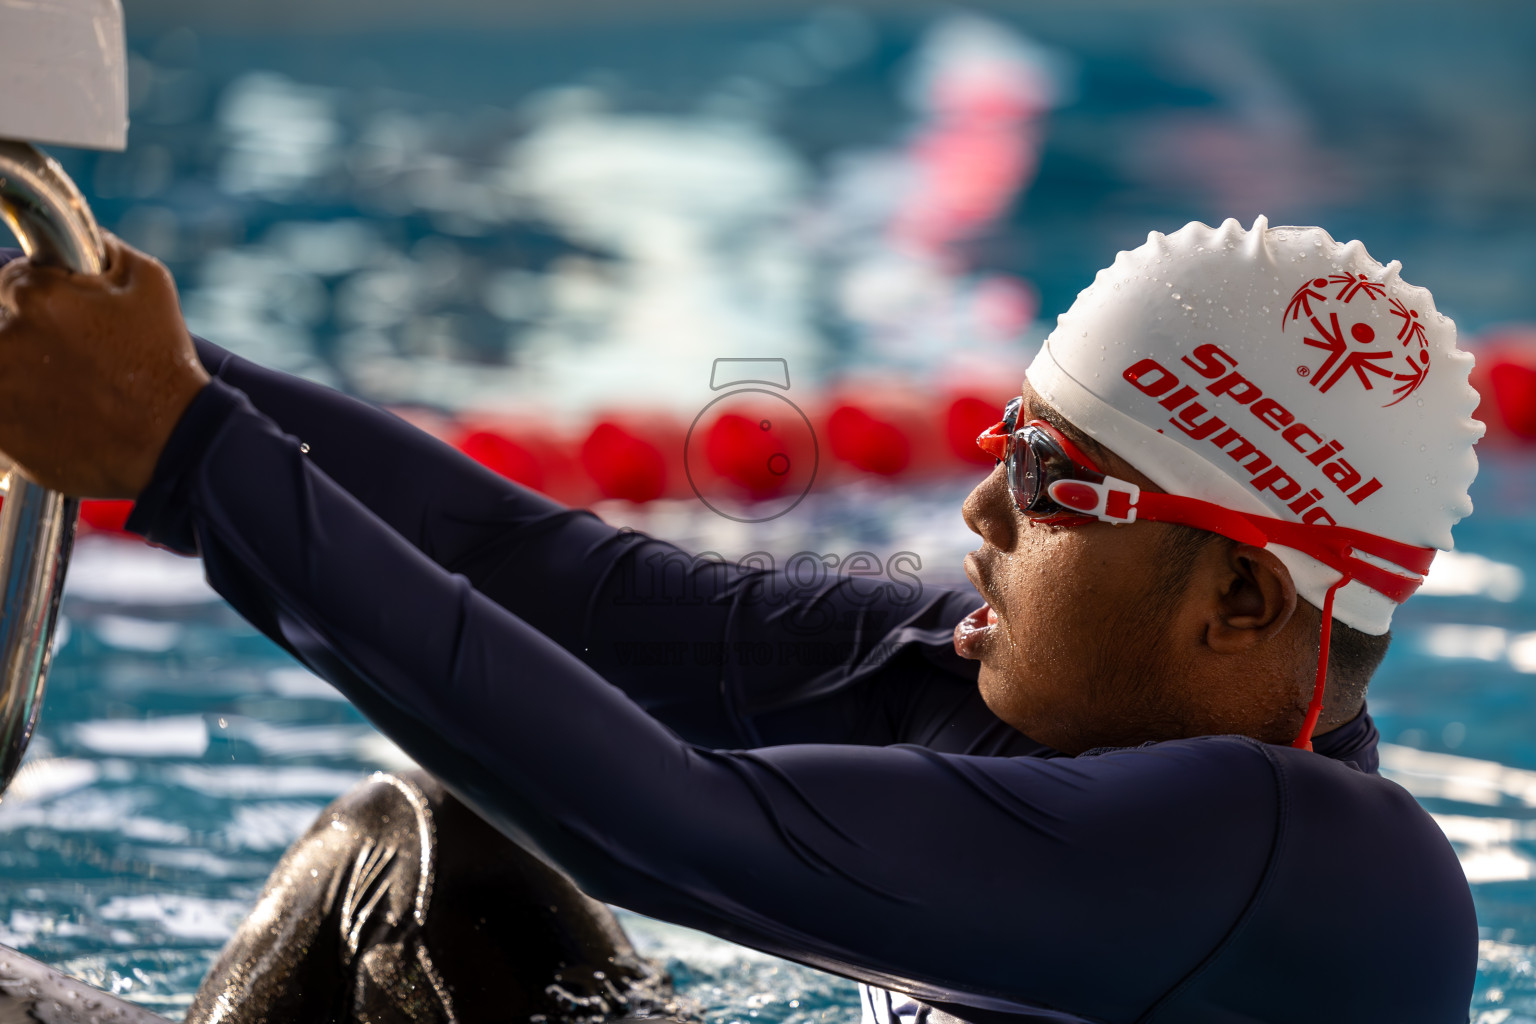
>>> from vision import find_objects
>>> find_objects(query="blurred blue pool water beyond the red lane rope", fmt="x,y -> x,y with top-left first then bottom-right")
42,0 -> 1536,418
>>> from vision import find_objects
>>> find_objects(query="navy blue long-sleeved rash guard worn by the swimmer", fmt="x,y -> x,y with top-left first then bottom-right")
0,244 -> 1476,1024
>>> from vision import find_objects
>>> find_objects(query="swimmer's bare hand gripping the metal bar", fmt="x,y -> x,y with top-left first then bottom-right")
0,235 -> 209,497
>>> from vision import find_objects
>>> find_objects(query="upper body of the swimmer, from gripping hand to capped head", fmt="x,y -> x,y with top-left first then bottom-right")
0,218 -> 1481,1024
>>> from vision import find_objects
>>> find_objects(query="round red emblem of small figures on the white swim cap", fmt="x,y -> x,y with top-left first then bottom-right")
1279,273 -> 1430,408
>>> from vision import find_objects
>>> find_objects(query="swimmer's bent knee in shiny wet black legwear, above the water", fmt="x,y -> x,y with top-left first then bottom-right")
186,774 -> 679,1024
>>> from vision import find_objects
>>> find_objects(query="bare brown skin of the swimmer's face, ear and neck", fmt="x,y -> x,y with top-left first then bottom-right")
955,382 -> 1353,754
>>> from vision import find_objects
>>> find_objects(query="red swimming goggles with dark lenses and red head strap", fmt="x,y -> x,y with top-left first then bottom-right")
975,398 -> 1435,751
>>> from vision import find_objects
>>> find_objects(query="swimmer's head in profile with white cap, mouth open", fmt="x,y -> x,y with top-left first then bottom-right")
966,218 -> 1482,749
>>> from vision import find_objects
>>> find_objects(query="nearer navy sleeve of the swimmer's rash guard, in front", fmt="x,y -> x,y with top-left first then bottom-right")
131,381 -> 1465,1021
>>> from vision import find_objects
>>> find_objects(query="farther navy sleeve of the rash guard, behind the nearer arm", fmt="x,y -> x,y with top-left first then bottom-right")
185,339 -> 1048,754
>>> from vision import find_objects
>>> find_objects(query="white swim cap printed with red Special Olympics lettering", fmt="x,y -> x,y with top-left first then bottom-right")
1026,216 -> 1484,634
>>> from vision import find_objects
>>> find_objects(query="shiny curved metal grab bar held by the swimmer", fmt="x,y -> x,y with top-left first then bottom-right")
0,140 -> 106,791
